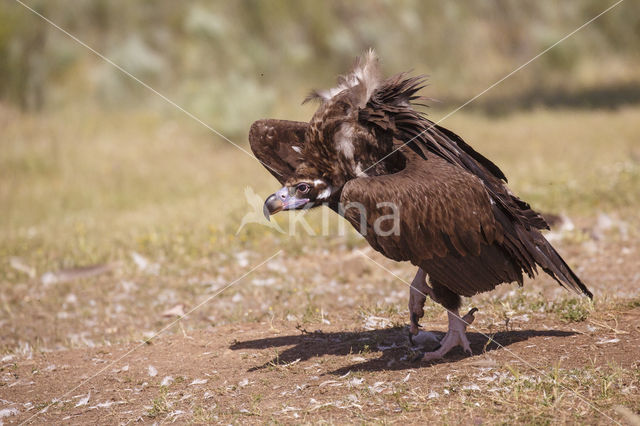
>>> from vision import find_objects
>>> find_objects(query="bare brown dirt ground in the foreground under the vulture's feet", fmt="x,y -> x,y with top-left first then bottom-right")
0,307 -> 640,424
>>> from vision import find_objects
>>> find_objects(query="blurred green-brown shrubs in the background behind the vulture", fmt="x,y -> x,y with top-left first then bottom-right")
0,0 -> 640,133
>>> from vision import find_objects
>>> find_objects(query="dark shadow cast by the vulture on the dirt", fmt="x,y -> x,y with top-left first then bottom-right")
229,327 -> 577,375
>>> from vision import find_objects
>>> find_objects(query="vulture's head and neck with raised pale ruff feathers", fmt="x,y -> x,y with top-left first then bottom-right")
263,50 -> 400,219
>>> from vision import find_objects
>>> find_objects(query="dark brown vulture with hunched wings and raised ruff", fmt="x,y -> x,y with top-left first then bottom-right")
249,52 -> 592,362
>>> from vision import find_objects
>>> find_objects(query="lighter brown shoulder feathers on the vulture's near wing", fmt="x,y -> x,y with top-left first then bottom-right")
340,150 -> 499,263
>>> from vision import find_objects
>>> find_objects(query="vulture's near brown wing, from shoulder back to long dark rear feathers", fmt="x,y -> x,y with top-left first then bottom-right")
340,148 -> 591,297
